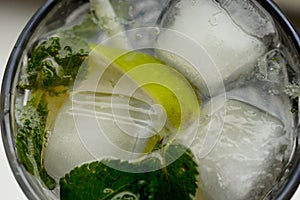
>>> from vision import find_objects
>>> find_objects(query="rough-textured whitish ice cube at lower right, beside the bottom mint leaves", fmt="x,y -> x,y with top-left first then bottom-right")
191,100 -> 290,200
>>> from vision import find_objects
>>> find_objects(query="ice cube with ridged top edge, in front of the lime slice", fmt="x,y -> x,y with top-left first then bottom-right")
45,93 -> 163,177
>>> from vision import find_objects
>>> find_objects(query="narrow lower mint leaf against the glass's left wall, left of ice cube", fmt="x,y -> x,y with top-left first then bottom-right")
16,92 -> 56,189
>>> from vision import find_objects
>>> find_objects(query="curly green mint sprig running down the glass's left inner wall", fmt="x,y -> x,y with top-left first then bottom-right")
16,37 -> 88,189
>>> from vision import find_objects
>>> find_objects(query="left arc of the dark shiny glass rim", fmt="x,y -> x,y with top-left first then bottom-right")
0,0 -> 58,200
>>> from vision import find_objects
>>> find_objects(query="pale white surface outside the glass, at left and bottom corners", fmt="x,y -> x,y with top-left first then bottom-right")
0,0 -> 300,200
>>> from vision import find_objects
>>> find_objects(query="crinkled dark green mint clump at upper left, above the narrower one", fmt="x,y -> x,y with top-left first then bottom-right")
18,37 -> 89,94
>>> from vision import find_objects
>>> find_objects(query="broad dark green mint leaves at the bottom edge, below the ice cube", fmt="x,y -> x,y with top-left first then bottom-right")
60,144 -> 198,200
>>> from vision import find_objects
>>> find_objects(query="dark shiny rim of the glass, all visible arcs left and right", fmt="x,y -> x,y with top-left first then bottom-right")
0,0 -> 300,200
